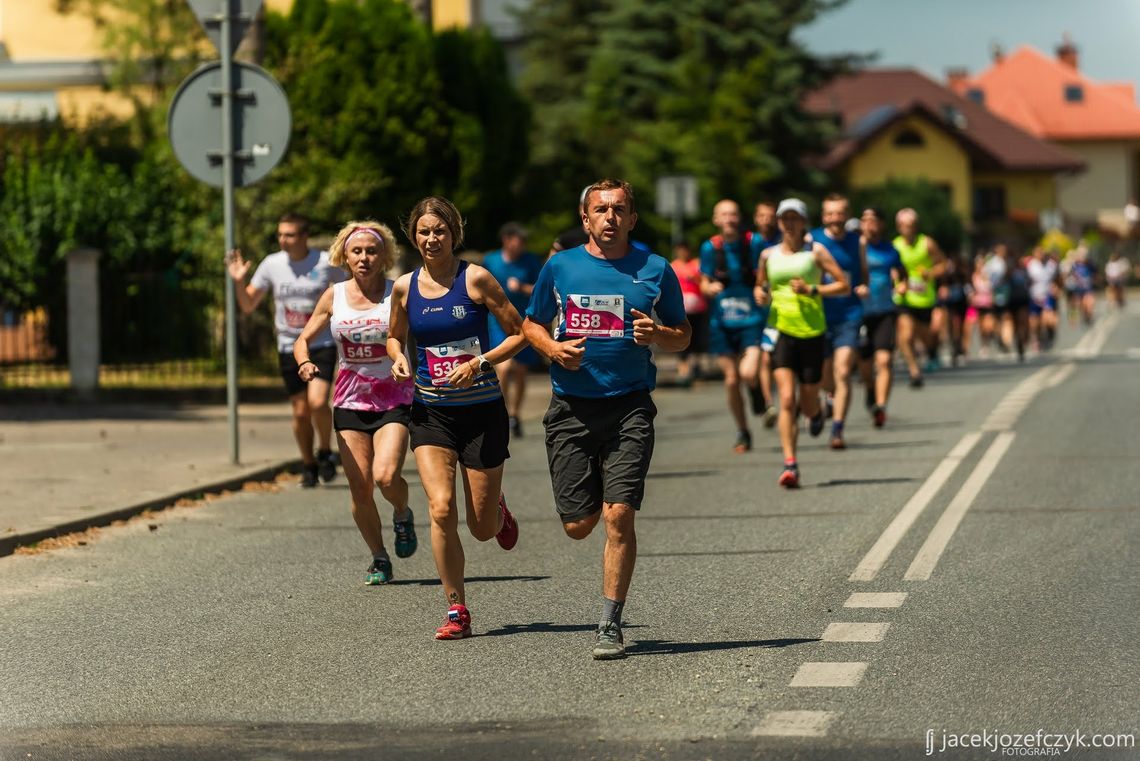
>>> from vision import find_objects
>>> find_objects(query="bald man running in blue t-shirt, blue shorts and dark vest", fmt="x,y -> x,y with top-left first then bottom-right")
701,199 -> 766,452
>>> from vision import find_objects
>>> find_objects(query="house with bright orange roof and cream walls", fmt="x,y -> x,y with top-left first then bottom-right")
948,39 -> 1140,223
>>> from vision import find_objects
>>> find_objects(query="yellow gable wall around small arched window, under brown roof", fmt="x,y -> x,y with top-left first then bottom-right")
846,116 -> 974,219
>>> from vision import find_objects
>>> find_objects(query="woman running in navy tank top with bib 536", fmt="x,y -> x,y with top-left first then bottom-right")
388,196 -> 524,639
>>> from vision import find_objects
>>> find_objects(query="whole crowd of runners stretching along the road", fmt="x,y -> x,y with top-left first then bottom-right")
228,180 -> 1129,660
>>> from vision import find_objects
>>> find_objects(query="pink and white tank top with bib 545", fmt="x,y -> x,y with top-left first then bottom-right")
329,280 -> 415,412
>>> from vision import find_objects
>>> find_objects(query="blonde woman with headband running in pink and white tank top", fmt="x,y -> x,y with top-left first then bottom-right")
293,221 -> 417,584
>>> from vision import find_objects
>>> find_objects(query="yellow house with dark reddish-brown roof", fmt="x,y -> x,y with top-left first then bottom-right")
804,68 -> 1084,234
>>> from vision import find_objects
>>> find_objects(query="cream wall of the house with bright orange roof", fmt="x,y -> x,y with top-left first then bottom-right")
1057,141 -> 1140,222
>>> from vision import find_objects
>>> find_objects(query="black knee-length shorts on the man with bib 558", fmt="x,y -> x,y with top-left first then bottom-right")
543,391 -> 657,523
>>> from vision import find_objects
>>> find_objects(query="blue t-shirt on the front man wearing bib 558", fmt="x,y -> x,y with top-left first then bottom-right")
527,246 -> 685,399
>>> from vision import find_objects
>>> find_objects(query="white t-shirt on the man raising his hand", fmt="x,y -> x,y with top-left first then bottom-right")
250,248 -> 349,353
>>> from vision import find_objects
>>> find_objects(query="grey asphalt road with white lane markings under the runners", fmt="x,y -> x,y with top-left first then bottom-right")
0,312 -> 1140,760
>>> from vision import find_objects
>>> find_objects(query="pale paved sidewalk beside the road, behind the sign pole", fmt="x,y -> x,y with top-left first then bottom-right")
0,375 -> 565,557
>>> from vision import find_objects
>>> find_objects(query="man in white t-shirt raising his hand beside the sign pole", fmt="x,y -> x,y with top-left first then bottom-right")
226,214 -> 348,489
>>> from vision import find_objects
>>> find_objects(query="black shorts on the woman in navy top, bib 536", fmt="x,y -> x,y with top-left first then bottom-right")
408,396 -> 511,470
